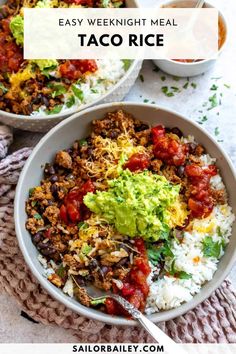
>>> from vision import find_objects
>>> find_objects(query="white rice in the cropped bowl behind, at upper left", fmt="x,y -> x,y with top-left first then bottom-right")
32,59 -> 126,117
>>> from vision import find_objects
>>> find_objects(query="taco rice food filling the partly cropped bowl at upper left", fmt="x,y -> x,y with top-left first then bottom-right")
0,0 -> 128,116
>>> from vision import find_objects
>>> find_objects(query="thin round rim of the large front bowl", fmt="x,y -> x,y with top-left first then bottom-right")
14,102 -> 236,326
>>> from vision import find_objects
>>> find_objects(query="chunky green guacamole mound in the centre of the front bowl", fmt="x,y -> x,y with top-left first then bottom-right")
84,170 -> 187,241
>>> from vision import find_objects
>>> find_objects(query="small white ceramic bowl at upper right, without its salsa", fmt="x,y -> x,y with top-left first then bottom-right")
153,0 -> 227,77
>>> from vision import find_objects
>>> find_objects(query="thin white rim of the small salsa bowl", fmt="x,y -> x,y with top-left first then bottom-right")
159,0 -> 229,66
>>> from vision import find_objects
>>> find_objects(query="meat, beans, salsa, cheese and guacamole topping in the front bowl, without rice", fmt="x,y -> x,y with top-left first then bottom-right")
26,110 -> 230,315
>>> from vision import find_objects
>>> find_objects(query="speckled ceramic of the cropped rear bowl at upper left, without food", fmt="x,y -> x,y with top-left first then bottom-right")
0,0 -> 142,132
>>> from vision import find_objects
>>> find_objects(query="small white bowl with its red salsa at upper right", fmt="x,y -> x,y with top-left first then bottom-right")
154,0 -> 227,77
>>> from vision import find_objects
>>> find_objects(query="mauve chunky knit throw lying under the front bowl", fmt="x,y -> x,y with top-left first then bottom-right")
0,126 -> 236,343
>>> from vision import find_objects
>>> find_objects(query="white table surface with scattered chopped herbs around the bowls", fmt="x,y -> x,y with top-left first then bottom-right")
0,0 -> 236,342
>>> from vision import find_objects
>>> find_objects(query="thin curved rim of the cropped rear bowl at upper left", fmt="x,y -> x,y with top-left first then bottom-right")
0,0 -> 142,122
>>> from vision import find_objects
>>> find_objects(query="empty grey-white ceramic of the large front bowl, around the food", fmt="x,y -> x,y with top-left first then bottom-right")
14,103 -> 236,325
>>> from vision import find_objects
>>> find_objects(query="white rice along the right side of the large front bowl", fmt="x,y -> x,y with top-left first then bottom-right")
146,151 -> 235,314
